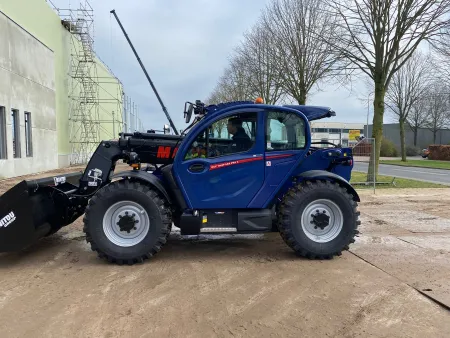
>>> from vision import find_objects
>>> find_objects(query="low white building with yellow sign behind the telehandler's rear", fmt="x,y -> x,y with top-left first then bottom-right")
311,121 -> 366,147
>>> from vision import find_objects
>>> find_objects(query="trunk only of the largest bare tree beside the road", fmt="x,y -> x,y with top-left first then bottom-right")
367,81 -> 386,182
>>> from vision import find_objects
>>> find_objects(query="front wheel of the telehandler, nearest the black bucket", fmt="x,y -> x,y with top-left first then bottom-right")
83,180 -> 172,265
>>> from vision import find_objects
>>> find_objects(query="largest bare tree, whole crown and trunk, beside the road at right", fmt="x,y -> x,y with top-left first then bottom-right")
324,0 -> 450,175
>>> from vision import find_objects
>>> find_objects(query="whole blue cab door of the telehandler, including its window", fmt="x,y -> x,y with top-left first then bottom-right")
173,110 -> 265,209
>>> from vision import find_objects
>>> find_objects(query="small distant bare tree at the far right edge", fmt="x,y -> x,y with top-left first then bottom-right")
425,81 -> 450,143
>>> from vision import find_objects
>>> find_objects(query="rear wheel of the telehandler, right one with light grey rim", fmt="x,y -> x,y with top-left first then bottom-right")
278,181 -> 360,259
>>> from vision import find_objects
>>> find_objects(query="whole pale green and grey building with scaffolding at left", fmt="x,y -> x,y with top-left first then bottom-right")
0,0 -> 142,178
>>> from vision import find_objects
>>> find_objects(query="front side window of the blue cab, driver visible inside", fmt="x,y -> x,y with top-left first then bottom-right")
184,113 -> 257,160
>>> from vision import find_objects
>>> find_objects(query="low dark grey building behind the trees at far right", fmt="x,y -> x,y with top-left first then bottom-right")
369,124 -> 450,149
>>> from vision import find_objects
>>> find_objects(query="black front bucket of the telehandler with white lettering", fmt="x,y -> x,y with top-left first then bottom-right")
0,173 -> 81,252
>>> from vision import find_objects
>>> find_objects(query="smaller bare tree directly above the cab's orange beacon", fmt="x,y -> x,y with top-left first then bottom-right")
236,22 -> 283,104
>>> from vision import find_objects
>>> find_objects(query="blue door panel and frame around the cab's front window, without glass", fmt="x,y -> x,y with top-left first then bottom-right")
173,105 -> 265,209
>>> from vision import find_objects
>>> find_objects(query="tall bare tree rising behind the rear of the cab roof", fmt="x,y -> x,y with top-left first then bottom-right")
261,0 -> 339,104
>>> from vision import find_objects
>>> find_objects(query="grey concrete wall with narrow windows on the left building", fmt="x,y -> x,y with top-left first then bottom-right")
0,12 -> 58,177
